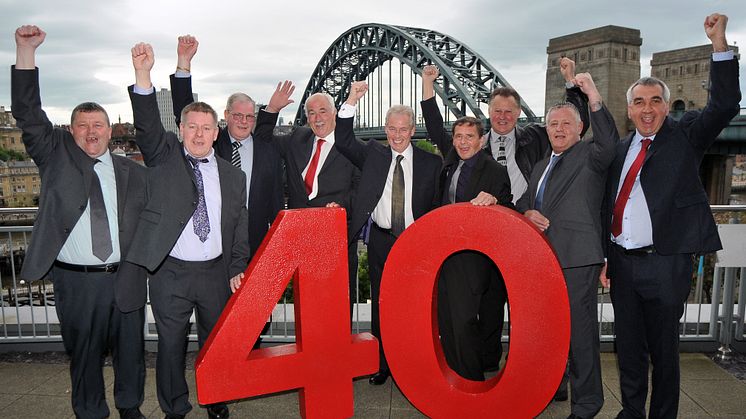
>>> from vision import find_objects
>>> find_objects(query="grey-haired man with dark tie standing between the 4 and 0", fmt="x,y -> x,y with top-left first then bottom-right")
334,81 -> 441,385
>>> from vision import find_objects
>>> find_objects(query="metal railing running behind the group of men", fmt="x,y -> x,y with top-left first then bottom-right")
0,205 -> 746,356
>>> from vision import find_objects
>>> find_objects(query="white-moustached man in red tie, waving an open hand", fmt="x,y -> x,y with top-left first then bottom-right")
254,81 -> 360,310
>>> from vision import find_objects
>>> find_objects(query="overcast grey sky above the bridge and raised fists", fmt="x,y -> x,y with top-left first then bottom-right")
0,0 -> 746,123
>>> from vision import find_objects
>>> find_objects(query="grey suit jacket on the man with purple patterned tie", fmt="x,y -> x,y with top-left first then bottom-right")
127,86 -> 249,281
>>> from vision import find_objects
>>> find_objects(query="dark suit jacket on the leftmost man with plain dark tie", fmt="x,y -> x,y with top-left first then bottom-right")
11,68 -> 147,312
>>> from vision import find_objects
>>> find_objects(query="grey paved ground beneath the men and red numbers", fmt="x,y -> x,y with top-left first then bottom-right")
0,353 -> 746,419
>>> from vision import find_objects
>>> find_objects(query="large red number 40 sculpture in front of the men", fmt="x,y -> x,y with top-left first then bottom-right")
196,204 -> 570,418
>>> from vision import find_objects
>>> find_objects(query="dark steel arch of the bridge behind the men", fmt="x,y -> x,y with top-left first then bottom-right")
295,23 -> 536,125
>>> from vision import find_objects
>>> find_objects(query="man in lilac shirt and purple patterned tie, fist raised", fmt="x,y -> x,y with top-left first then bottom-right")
127,44 -> 249,418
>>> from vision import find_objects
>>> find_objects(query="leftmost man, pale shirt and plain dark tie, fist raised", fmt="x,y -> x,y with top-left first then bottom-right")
11,26 -> 146,419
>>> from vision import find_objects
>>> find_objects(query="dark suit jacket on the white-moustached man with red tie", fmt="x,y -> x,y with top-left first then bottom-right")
254,110 -> 360,212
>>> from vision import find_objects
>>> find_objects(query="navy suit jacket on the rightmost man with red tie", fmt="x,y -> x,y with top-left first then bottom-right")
604,59 -> 741,255
